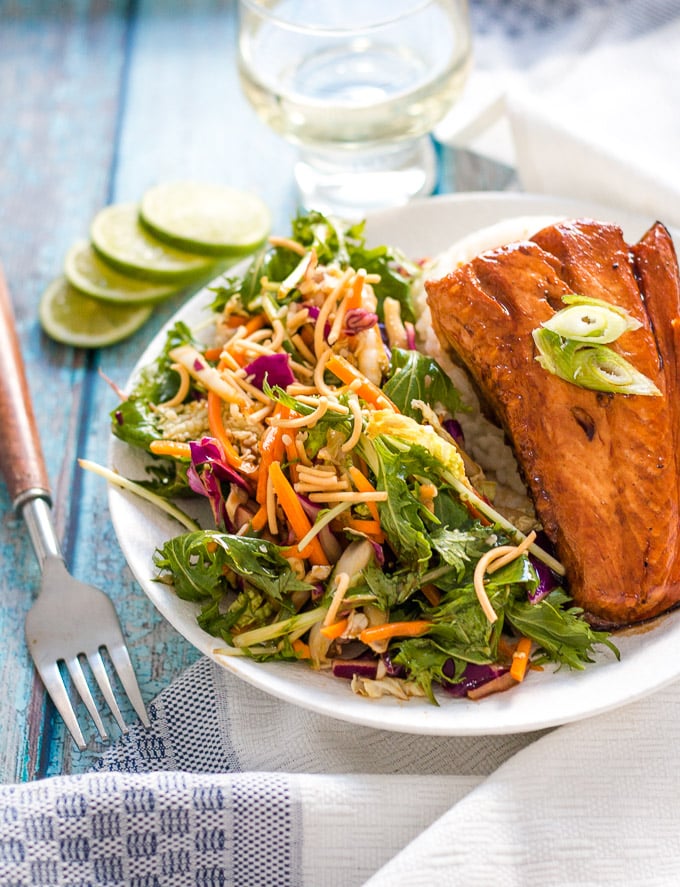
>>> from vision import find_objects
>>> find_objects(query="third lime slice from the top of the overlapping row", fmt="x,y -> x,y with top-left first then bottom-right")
64,240 -> 179,305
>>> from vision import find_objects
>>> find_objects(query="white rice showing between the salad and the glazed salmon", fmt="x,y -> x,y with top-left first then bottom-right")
416,216 -> 558,511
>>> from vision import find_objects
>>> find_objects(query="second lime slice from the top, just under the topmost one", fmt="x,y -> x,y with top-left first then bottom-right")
90,203 -> 215,284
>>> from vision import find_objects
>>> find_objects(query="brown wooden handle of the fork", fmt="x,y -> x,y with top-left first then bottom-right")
0,265 -> 50,509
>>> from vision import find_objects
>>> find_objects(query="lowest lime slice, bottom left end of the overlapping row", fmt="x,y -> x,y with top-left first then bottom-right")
38,277 -> 152,348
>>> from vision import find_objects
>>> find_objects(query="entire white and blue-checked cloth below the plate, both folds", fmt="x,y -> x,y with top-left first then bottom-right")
0,659 -> 680,887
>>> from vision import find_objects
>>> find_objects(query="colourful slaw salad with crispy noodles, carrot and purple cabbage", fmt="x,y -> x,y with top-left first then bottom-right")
102,212 -> 617,703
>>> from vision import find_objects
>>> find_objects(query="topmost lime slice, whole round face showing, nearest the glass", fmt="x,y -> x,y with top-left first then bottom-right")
140,181 -> 271,256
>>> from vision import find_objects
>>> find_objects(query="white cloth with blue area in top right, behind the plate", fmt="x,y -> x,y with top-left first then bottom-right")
437,0 -> 680,227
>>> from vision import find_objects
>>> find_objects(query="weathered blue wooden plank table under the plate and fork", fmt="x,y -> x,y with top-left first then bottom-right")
0,0 -> 510,782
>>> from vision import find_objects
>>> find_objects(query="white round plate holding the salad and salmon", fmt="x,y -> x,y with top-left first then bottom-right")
109,193 -> 680,736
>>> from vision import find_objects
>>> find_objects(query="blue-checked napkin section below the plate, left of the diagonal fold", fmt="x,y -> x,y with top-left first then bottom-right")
0,659 -> 535,887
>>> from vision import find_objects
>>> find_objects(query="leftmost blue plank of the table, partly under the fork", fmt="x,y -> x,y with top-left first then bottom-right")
0,2 -> 134,782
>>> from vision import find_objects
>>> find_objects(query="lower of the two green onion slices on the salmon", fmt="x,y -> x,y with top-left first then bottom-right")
532,327 -> 661,397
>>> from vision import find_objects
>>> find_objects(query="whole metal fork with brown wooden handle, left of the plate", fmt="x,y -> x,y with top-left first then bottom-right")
0,265 -> 149,751
